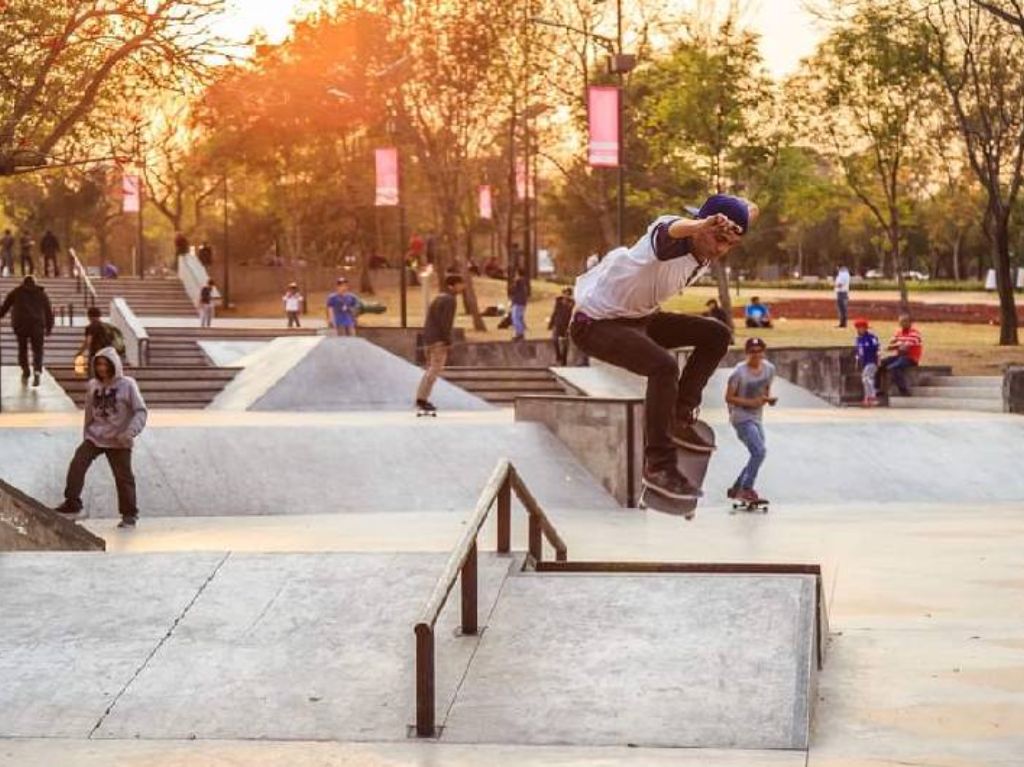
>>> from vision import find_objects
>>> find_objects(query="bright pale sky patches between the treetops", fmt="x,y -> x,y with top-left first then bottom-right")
219,0 -> 822,78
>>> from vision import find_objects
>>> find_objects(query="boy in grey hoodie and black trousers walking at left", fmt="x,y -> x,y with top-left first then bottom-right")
57,347 -> 147,527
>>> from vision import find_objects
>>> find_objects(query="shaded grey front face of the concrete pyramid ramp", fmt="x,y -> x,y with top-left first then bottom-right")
250,337 -> 490,412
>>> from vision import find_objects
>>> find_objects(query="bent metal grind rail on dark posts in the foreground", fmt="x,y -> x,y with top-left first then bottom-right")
415,459 -> 568,737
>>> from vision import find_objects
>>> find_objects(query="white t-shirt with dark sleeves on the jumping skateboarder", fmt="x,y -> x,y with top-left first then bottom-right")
574,216 -> 708,319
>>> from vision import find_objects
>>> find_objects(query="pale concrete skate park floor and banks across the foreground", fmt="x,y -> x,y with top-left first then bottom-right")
0,342 -> 1024,767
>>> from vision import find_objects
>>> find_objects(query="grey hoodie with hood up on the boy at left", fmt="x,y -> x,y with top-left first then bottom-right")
85,346 -> 147,448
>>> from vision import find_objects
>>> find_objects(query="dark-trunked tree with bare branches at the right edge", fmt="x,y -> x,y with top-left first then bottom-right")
925,0 -> 1024,346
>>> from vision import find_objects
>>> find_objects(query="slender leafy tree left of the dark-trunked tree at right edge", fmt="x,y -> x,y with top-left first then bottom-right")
791,1 -> 934,311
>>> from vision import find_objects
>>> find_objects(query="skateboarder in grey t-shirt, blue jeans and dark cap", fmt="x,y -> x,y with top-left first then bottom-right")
725,338 -> 777,503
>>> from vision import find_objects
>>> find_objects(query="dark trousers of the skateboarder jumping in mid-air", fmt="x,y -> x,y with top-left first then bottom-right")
569,311 -> 729,469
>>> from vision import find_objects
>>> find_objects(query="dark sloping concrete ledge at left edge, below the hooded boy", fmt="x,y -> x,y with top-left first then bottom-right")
0,479 -> 106,551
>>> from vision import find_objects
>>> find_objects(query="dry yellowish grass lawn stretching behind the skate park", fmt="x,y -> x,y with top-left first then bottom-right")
228,279 -> 1024,375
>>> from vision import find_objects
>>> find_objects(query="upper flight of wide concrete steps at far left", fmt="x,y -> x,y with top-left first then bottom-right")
0,274 -> 196,313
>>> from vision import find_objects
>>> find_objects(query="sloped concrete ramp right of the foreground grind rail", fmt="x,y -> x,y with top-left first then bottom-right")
442,573 -> 816,750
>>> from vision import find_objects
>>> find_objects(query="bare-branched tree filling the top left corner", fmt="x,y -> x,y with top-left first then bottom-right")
0,0 -> 223,173
